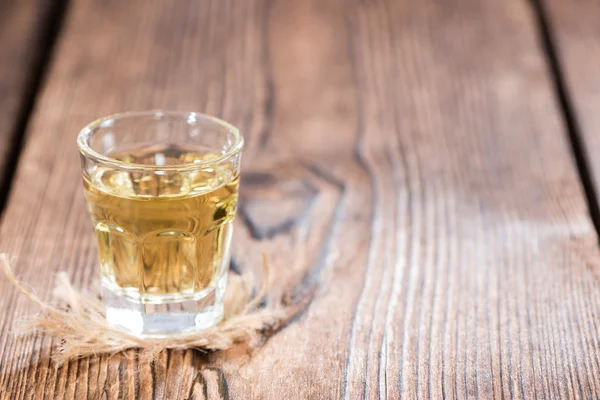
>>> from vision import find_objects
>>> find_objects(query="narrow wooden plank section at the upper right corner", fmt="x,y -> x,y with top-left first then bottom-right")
540,0 -> 600,212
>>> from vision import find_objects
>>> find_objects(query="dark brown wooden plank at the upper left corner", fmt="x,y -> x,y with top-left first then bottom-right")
0,0 -> 57,199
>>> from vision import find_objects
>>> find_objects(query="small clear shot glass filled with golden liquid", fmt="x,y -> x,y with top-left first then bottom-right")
77,111 -> 244,337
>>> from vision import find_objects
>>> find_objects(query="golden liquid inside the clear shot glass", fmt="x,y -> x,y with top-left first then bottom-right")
84,147 -> 238,302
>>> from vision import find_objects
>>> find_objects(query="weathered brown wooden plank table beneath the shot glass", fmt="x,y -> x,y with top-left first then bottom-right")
0,0 -> 600,399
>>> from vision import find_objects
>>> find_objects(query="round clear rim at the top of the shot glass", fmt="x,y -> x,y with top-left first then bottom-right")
77,110 -> 244,171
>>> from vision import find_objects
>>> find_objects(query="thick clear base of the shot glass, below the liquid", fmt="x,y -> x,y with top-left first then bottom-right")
102,273 -> 227,337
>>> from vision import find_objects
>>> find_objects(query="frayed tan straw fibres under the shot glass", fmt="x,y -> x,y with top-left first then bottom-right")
0,253 -> 314,364
